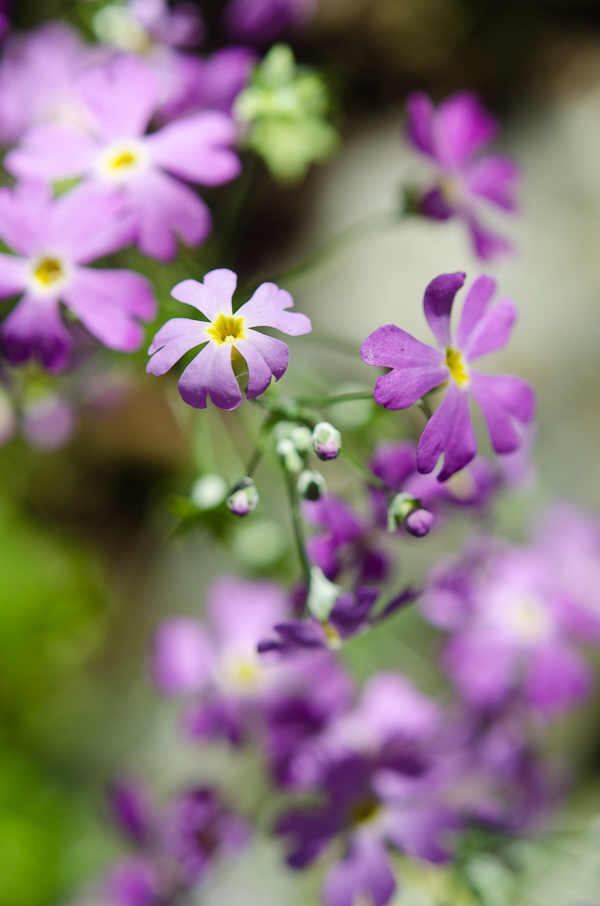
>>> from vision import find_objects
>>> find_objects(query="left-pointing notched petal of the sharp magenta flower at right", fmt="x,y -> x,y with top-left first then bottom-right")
360,324 -> 450,409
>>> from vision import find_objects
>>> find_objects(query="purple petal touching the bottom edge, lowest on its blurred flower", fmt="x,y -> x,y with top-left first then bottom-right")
322,834 -> 396,906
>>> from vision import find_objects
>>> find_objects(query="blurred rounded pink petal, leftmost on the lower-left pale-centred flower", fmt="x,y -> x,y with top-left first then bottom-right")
152,617 -> 214,695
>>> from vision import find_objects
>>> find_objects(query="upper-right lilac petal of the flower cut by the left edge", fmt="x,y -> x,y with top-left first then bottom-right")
48,183 -> 135,264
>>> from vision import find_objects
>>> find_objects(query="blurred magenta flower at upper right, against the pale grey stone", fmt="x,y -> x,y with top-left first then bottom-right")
407,91 -> 519,260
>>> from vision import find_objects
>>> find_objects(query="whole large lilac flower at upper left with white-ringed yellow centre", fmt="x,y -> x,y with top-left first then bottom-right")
5,56 -> 240,261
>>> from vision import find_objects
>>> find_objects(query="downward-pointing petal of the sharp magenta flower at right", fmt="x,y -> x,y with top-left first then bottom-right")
417,381 -> 477,481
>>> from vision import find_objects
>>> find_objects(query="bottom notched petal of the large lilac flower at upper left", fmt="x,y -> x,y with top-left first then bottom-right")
127,170 -> 211,261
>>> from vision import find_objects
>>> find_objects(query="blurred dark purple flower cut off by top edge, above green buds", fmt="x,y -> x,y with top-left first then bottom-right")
225,0 -> 316,44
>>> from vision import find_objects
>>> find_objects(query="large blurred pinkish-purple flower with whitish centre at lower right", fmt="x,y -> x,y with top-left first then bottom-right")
422,540 -> 591,716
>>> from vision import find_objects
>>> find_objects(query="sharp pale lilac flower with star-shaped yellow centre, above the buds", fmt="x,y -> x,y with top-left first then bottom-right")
146,268 -> 311,409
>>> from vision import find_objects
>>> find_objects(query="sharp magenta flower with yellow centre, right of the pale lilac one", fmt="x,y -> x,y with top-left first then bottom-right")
361,273 -> 535,481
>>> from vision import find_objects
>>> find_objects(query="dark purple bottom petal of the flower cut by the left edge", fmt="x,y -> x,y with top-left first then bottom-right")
2,295 -> 73,371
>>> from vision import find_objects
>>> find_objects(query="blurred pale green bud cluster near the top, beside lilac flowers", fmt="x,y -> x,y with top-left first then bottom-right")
234,44 -> 338,182
